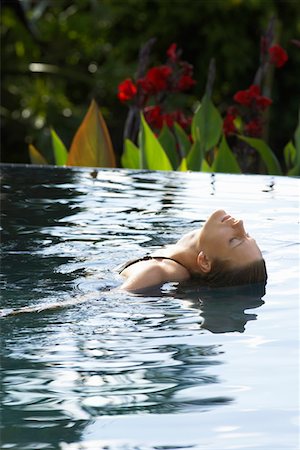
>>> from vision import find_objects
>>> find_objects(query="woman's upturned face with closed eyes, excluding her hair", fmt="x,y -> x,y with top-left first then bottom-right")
199,210 -> 262,268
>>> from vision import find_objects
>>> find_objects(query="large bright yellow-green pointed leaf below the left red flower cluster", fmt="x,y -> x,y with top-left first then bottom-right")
140,114 -> 173,170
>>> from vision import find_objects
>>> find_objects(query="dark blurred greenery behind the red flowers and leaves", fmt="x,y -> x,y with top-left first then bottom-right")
1,0 -> 300,163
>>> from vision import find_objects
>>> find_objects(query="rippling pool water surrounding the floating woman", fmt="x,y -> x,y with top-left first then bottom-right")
0,166 -> 299,450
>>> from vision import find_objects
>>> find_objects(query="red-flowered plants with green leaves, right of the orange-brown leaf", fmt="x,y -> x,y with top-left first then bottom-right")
114,20 -> 298,175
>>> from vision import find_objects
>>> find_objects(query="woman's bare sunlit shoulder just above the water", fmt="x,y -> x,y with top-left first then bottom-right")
121,260 -> 189,292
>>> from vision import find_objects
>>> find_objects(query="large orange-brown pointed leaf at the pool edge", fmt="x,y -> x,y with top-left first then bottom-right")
67,100 -> 116,167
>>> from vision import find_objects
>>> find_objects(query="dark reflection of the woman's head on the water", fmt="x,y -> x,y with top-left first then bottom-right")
176,283 -> 265,333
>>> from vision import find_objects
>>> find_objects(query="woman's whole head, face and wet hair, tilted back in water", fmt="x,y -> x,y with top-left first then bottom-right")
193,210 -> 267,286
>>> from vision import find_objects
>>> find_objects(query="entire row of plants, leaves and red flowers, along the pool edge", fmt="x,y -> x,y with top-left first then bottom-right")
29,27 -> 300,175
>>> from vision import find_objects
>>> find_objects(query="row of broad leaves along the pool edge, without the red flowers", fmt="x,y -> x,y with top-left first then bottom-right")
29,94 -> 300,176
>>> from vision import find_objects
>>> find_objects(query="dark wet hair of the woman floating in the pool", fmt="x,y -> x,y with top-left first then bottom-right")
197,259 -> 268,287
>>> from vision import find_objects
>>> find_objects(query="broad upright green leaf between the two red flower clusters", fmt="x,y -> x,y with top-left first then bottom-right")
192,94 -> 223,153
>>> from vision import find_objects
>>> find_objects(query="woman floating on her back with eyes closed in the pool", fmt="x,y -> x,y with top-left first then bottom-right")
118,210 -> 267,292
